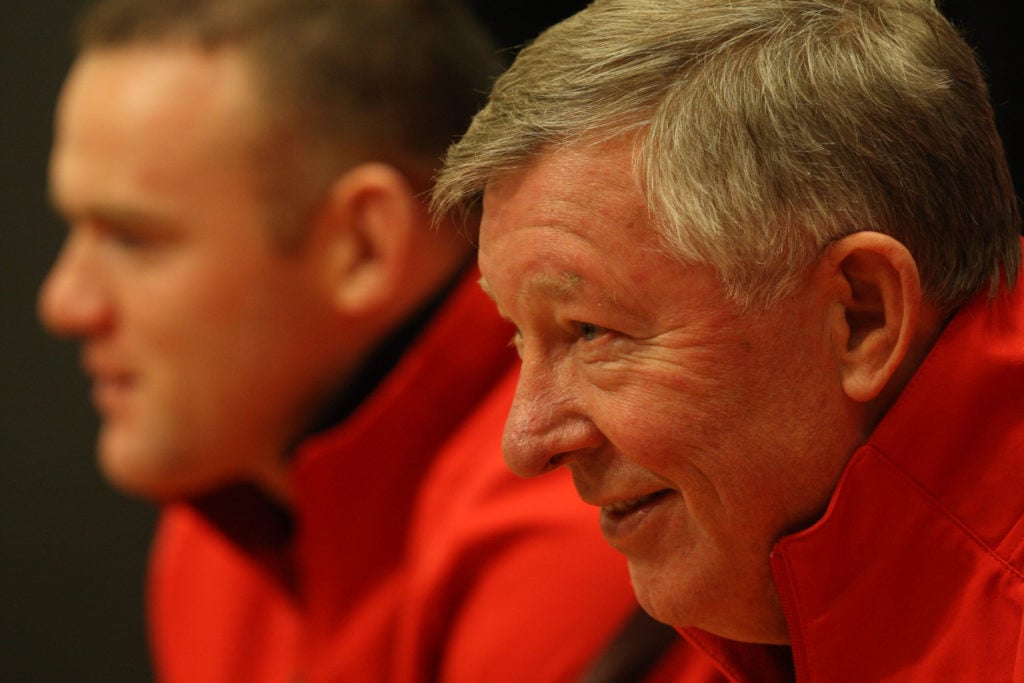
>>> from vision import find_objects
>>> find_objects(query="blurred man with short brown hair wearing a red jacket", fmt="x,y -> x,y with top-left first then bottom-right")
40,0 -> 655,683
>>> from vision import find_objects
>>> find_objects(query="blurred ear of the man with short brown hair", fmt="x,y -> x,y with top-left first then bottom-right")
317,163 -> 427,316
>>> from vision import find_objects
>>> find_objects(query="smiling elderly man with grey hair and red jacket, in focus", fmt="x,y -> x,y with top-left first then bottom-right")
434,0 -> 1024,683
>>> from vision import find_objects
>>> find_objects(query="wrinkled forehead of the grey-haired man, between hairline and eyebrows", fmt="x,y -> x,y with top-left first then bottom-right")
478,147 -> 671,309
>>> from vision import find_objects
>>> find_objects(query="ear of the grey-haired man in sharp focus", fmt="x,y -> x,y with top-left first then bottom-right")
819,232 -> 922,402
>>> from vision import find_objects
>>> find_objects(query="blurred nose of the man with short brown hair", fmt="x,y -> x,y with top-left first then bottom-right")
38,228 -> 113,337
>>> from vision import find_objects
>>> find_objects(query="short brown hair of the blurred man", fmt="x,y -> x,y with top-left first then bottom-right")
77,0 -> 504,242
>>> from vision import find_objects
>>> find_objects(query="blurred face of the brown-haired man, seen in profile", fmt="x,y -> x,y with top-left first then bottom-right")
40,46 -> 344,498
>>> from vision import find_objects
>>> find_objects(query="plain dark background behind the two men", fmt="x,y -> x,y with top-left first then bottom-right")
0,0 -> 1024,683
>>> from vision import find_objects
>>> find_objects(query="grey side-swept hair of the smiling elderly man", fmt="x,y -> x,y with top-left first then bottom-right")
433,0 -> 1020,310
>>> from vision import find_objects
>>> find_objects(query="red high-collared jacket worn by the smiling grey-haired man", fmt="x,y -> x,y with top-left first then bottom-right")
684,270 -> 1024,683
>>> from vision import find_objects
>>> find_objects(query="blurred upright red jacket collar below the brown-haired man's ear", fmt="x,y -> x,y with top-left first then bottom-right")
286,268 -> 515,647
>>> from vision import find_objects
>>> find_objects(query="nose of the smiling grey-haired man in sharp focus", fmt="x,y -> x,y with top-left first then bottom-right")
502,355 -> 600,477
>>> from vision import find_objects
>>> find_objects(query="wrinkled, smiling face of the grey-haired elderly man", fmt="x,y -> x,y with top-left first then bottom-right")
479,144 -> 859,642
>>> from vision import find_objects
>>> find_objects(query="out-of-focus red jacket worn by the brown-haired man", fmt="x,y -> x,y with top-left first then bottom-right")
150,274 -> 647,683
